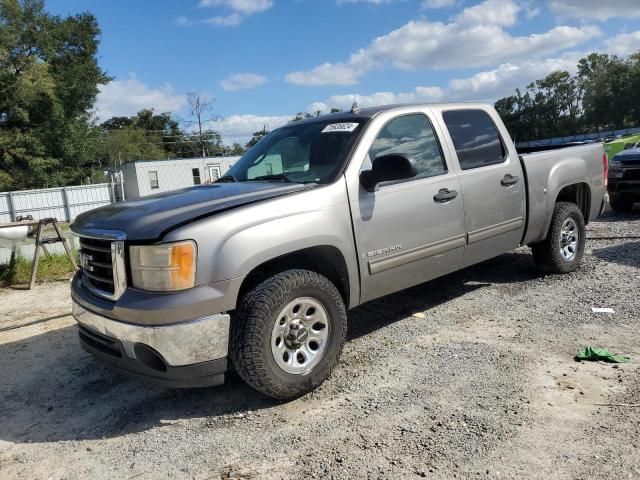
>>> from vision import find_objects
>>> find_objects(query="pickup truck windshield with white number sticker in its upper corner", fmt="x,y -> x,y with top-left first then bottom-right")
224,119 -> 366,183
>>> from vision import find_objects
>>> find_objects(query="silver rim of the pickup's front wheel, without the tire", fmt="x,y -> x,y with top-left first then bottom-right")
271,297 -> 330,375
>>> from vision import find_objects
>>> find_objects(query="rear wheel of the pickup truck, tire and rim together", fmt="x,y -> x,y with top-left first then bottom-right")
531,202 -> 586,273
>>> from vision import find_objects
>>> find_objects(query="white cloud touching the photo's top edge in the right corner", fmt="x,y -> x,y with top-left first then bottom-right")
549,0 -> 640,20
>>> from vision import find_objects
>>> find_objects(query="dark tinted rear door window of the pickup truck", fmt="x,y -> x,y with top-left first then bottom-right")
442,110 -> 506,170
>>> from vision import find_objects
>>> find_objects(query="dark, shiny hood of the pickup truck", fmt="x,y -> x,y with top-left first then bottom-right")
71,182 -> 313,240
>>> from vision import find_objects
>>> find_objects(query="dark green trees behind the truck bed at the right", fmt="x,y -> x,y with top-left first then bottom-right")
495,51 -> 640,141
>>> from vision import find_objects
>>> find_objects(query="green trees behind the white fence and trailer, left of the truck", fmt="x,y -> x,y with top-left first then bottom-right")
0,0 -> 246,191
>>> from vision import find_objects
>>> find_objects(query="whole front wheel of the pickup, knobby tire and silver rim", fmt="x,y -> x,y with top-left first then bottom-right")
230,270 -> 347,400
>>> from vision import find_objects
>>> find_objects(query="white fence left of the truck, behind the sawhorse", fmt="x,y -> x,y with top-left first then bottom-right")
0,183 -> 112,223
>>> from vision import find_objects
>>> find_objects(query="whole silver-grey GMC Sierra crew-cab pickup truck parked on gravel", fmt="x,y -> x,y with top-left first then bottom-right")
71,104 -> 607,399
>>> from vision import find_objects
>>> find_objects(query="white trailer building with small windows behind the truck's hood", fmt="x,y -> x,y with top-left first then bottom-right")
122,157 -> 240,200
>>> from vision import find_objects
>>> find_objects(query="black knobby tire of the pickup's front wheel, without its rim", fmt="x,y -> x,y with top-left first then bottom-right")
230,270 -> 347,400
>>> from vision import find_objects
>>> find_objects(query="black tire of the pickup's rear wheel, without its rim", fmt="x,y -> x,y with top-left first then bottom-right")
531,202 -> 586,273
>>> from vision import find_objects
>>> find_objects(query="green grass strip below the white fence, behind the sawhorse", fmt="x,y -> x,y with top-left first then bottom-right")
0,252 -> 78,287
